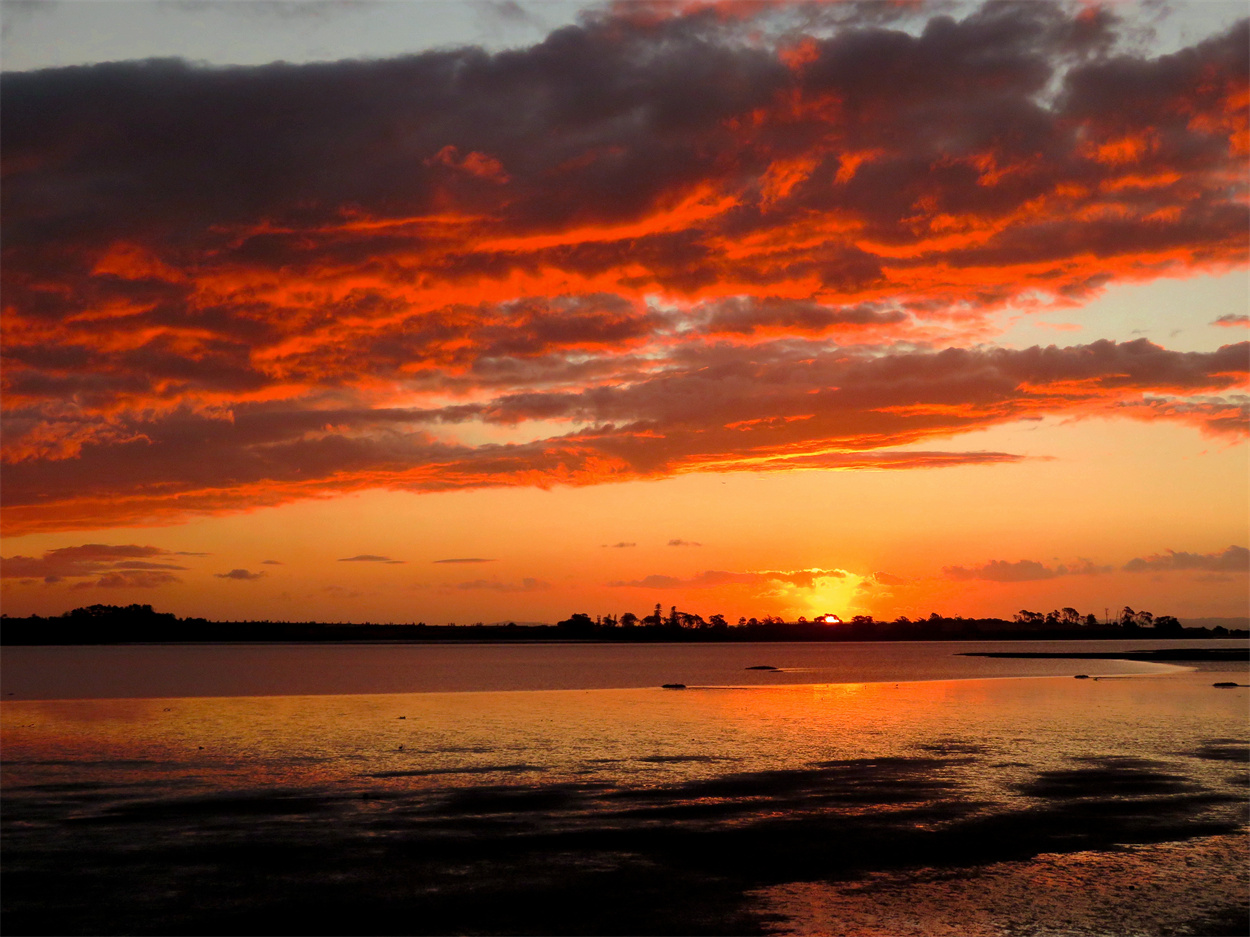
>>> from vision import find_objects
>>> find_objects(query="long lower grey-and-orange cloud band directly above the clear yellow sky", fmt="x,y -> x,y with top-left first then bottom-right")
3,339 -> 1250,530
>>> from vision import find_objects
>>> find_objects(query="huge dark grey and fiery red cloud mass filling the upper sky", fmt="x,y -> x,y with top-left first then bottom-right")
0,4 -> 1250,533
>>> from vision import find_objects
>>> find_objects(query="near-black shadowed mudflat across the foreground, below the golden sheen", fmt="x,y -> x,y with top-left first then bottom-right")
4,743 -> 1250,936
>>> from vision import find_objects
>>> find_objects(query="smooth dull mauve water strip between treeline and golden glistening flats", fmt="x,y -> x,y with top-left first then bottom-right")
0,641 -> 1230,700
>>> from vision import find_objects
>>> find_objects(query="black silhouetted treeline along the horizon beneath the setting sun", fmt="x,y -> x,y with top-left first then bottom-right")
0,605 -> 1248,645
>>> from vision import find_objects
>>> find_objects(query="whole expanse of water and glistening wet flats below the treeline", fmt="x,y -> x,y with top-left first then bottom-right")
0,640 -> 1250,937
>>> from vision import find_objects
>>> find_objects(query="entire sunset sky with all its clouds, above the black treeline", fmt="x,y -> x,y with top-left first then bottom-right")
0,0 -> 1250,632
